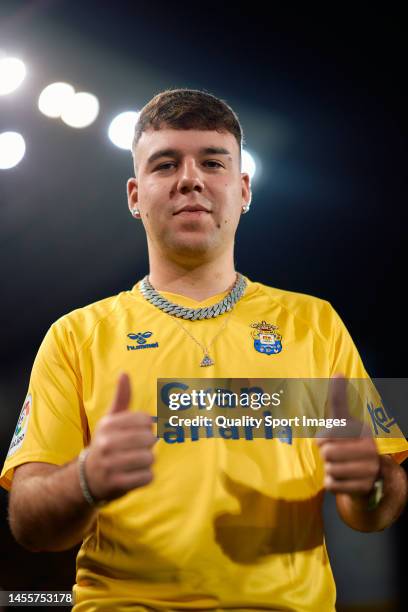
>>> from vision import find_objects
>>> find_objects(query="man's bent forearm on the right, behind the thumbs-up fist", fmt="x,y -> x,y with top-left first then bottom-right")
336,455 -> 408,532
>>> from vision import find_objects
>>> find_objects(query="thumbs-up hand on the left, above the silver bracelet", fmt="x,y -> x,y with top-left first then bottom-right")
85,374 -> 157,501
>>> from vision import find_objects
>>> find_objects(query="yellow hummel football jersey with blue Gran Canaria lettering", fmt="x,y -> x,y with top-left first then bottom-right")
0,279 -> 408,612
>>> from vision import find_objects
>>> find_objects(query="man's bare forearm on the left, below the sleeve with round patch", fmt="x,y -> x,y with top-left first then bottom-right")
9,460 -> 95,552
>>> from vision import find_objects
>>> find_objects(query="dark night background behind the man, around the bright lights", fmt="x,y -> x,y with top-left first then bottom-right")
0,0 -> 408,611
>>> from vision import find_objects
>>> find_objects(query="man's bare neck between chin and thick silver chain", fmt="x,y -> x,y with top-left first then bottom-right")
149,251 -> 236,302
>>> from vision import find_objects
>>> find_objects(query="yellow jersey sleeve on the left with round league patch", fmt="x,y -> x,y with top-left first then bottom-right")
0,319 -> 88,489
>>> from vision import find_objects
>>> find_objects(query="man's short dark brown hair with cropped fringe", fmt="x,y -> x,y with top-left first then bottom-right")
132,89 -> 244,161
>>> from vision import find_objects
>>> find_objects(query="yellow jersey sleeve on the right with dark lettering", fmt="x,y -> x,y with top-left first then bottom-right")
329,308 -> 408,463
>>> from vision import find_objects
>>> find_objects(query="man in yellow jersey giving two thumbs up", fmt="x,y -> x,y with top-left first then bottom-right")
1,90 -> 408,612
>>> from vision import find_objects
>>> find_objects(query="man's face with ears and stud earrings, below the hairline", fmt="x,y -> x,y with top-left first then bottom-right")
128,128 -> 250,262
